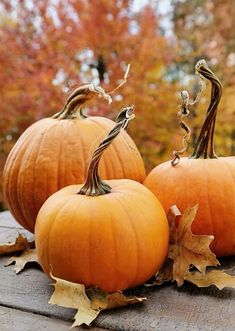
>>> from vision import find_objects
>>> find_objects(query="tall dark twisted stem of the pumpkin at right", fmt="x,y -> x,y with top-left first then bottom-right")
191,60 -> 222,159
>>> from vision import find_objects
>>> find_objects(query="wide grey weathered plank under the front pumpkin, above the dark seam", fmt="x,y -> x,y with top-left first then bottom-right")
0,213 -> 235,331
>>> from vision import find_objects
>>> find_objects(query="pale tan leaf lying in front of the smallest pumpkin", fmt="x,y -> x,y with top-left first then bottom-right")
49,275 -> 146,327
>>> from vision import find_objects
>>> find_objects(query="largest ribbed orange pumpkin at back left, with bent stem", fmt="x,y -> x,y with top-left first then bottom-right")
3,84 -> 145,232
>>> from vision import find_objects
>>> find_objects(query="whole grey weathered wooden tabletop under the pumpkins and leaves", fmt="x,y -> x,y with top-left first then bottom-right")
0,212 -> 235,331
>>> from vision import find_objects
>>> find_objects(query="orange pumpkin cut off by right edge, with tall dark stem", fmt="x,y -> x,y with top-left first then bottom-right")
144,60 -> 235,256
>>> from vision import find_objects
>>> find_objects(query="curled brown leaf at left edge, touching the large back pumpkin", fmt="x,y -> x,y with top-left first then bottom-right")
0,233 -> 35,255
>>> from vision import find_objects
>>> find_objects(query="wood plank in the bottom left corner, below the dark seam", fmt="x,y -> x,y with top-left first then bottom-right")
0,306 -> 105,331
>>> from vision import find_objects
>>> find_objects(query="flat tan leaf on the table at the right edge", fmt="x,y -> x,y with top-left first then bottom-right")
185,270 -> 235,290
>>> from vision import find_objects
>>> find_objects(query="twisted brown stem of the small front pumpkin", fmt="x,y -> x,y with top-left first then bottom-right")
78,106 -> 135,196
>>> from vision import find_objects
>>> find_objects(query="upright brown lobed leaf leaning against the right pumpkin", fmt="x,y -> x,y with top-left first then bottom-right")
168,205 -> 219,286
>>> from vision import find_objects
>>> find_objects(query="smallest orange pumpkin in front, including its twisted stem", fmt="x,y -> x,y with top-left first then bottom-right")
35,108 -> 169,292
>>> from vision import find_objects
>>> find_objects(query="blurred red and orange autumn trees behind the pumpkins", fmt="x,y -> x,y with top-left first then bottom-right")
0,0 -> 235,210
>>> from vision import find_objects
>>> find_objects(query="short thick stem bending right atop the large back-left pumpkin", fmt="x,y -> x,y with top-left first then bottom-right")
53,84 -> 112,119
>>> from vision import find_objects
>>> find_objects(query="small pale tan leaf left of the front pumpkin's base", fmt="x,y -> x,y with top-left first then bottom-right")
5,248 -> 39,274
